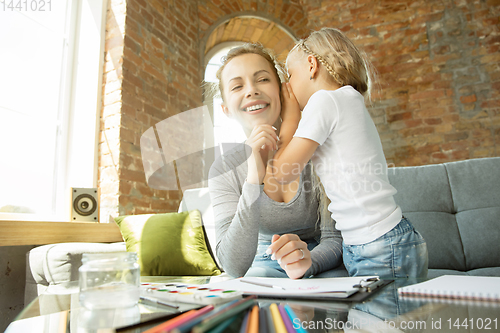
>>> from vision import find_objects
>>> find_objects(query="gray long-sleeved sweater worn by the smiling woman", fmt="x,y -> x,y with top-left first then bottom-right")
208,144 -> 342,277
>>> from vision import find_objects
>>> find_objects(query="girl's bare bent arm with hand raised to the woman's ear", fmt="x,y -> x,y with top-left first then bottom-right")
271,83 -> 319,184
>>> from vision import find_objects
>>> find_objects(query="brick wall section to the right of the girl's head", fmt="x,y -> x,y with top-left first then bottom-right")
303,0 -> 500,166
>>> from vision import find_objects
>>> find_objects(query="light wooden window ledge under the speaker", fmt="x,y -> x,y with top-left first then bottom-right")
0,221 -> 123,246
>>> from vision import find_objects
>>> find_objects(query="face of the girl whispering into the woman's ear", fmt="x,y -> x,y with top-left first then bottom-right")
286,51 -> 312,110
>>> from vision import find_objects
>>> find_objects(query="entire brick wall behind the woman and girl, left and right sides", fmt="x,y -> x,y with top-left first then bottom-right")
99,0 -> 500,220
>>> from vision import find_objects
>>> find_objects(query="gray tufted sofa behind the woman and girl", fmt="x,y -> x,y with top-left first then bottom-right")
25,157 -> 500,304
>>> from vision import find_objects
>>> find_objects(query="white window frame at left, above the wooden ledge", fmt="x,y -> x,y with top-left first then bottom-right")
0,0 -> 107,223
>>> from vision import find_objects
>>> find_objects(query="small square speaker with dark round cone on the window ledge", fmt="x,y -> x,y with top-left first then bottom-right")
71,187 -> 99,222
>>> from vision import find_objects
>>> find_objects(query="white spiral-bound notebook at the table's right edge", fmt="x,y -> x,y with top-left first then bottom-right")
398,275 -> 500,302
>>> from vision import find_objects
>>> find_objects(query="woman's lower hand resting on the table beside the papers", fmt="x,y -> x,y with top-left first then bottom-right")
266,234 -> 312,279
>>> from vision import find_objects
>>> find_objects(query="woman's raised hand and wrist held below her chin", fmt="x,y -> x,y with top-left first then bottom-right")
245,124 -> 278,185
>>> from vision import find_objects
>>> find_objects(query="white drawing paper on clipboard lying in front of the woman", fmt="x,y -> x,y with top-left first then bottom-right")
203,276 -> 386,299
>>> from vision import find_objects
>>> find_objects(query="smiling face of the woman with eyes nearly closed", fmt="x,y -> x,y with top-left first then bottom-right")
221,53 -> 281,136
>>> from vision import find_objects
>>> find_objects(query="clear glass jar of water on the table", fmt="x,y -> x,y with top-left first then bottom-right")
79,252 -> 140,309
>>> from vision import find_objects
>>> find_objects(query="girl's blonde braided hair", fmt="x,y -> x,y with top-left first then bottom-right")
289,28 -> 372,97
